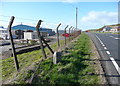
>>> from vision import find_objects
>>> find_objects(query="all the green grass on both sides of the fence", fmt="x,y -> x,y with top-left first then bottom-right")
2,33 -> 100,85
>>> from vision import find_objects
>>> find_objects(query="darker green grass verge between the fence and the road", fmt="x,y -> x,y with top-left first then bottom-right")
32,33 -> 100,85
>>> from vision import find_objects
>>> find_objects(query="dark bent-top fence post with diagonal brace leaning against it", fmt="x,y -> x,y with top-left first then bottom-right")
36,20 -> 47,59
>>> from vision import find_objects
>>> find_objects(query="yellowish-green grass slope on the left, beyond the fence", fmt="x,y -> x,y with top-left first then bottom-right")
0,40 -> 67,83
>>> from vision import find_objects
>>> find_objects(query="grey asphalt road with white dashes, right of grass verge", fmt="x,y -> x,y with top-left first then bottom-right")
87,33 -> 120,85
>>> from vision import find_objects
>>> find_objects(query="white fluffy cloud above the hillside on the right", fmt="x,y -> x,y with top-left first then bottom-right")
80,11 -> 118,28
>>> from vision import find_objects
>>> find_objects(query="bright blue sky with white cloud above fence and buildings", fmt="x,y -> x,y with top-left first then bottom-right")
0,0 -> 118,31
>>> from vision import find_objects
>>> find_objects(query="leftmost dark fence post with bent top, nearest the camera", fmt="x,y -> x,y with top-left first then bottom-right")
8,16 -> 19,71
